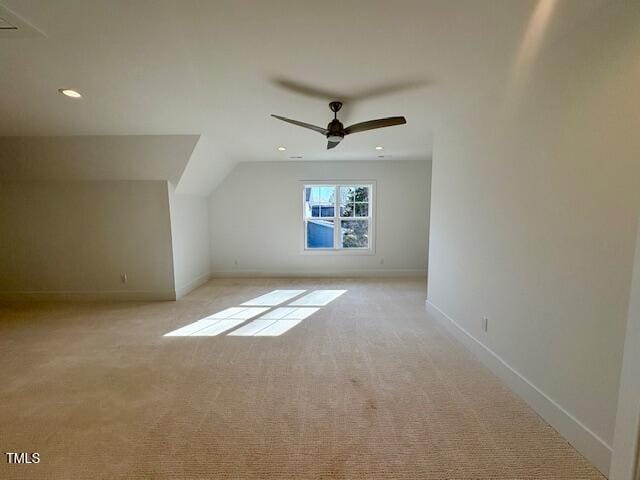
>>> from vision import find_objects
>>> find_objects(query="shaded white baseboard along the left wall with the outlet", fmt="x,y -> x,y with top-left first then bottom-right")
0,290 -> 176,302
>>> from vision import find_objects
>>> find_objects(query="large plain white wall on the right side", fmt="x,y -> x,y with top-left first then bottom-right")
428,2 -> 640,471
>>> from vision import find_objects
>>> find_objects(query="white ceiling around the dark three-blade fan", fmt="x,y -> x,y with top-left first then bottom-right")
0,0 -> 607,194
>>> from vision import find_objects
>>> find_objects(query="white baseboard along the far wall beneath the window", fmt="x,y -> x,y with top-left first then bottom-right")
211,269 -> 427,278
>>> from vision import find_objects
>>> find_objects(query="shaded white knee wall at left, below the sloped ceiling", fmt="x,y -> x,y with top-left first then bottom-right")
0,181 -> 175,299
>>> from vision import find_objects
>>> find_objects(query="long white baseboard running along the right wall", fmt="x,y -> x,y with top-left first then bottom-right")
426,300 -> 612,475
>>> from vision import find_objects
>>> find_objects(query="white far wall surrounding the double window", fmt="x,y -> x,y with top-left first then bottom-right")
210,161 -> 431,275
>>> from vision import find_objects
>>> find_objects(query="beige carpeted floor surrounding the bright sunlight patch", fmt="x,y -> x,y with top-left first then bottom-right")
0,279 -> 602,480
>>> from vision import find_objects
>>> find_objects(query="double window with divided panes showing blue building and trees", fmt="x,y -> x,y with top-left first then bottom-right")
303,183 -> 373,251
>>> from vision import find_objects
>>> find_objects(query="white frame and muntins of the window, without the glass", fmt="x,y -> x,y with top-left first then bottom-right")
300,180 -> 376,255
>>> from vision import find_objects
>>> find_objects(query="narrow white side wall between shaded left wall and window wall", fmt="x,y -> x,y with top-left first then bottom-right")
170,186 -> 211,298
